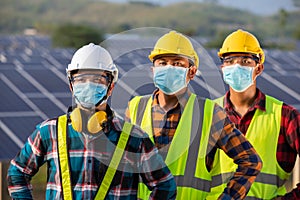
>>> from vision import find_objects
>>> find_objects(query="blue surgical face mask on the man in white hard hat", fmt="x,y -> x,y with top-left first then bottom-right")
73,82 -> 107,108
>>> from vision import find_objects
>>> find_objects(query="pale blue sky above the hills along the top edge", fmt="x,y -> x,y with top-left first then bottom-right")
107,0 -> 296,16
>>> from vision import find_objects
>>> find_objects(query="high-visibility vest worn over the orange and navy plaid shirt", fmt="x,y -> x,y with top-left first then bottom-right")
129,94 -> 214,199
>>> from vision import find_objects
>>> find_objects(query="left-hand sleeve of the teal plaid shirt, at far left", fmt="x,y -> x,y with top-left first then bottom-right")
7,122 -> 43,199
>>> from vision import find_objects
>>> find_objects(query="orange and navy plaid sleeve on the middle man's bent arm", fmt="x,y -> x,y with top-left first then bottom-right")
210,105 -> 262,199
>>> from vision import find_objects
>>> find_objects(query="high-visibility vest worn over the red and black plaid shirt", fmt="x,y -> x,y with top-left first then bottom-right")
208,95 -> 290,199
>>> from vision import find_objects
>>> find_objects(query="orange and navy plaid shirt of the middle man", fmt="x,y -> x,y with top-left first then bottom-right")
126,90 -> 262,199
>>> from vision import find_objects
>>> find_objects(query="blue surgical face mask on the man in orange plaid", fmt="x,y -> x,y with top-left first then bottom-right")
153,65 -> 189,95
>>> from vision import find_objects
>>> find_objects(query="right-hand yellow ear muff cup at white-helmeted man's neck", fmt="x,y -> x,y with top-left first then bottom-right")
87,111 -> 107,134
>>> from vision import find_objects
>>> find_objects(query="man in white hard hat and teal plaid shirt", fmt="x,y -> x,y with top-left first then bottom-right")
7,43 -> 176,200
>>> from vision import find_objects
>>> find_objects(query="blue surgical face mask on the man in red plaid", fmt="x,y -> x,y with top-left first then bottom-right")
222,64 -> 254,92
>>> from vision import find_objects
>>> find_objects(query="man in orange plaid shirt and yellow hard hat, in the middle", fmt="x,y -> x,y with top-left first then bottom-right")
125,31 -> 262,199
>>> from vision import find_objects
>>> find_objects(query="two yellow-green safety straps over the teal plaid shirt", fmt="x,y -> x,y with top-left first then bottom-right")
57,115 -> 132,200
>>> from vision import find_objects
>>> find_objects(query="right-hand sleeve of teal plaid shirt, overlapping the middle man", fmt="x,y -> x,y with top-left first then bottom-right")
135,126 -> 176,199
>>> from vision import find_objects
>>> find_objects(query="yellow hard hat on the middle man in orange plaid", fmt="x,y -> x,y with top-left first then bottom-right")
148,31 -> 199,68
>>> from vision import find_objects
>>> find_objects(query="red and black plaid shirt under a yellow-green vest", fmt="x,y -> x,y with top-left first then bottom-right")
224,89 -> 300,200
